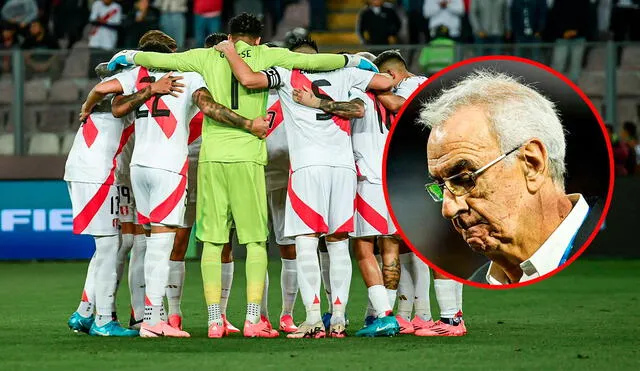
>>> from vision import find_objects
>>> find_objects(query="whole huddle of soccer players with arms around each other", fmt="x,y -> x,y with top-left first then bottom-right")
65,13 -> 466,338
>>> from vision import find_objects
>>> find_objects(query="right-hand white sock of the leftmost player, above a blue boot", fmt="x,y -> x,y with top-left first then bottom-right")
94,235 -> 120,326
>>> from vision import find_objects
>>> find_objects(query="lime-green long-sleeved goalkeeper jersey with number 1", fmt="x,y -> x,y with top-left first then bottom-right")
135,41 -> 346,165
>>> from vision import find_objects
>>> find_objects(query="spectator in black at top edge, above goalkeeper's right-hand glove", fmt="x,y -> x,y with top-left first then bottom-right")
356,0 -> 402,45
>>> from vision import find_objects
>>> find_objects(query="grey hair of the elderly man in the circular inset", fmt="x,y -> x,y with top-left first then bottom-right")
418,70 -> 567,189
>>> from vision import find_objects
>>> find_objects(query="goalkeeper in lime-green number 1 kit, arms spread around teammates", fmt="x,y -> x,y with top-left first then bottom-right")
109,13 -> 377,338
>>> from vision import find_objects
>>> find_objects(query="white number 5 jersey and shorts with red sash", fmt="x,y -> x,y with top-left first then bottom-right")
267,67 -> 375,237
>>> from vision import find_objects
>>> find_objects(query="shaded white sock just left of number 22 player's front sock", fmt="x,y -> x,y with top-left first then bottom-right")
128,234 -> 147,321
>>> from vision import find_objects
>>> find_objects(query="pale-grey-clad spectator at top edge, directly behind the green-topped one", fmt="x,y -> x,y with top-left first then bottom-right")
423,0 -> 465,40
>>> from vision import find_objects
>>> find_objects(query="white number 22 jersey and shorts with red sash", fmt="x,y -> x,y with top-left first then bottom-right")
115,67 -> 206,226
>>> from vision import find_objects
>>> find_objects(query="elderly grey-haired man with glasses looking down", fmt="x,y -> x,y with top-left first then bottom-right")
420,72 -> 589,285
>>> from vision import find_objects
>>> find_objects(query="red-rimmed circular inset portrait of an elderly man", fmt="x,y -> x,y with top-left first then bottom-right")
384,57 -> 613,288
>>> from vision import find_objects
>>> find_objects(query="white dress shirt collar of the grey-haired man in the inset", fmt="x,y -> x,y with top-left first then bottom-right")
486,193 -> 589,285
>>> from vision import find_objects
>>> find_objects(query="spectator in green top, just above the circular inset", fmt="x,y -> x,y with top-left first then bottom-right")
419,25 -> 456,76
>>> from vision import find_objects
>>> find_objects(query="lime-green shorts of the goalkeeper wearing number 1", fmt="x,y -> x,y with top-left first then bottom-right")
196,162 -> 269,244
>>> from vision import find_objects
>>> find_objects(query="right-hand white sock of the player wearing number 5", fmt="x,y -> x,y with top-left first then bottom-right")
327,239 -> 353,324
